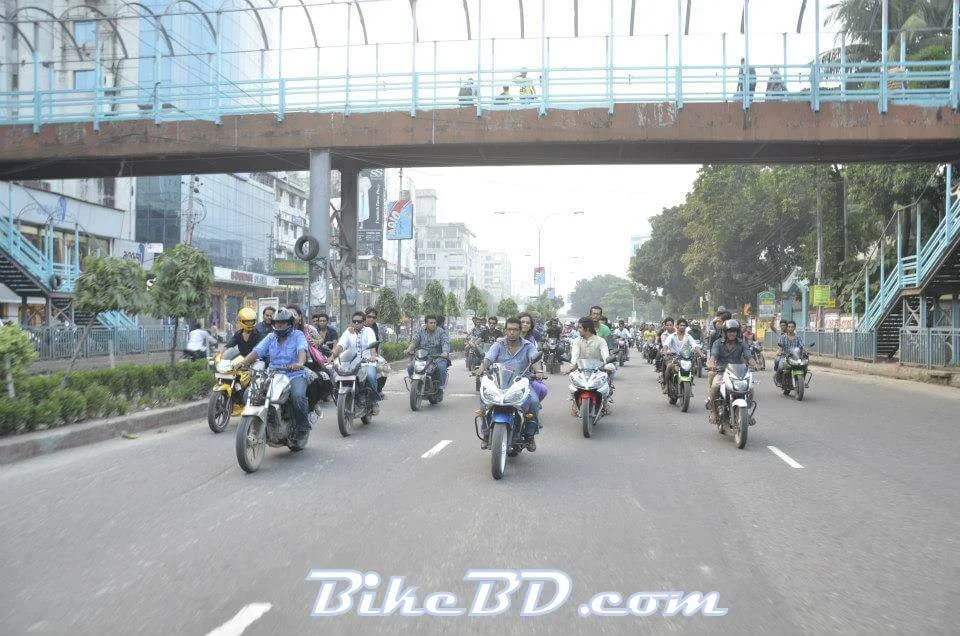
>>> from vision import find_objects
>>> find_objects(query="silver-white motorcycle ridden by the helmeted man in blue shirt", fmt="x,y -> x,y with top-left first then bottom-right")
236,361 -> 316,473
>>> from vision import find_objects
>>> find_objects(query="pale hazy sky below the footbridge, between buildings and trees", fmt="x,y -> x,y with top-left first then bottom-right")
404,166 -> 698,295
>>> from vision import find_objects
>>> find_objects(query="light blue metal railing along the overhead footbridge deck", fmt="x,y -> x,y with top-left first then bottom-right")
0,56 -> 960,131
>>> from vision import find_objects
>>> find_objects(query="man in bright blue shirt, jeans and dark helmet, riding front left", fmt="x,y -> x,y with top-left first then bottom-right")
237,307 -> 310,435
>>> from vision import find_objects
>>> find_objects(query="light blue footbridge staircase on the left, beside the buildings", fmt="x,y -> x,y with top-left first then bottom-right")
0,221 -> 139,327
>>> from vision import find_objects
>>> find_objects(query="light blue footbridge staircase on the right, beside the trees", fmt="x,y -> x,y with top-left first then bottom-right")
857,186 -> 960,358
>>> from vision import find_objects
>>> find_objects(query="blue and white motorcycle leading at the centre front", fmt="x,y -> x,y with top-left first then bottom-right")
473,353 -> 543,479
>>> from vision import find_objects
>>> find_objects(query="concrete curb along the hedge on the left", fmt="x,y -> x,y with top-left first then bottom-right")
0,400 -> 207,466
